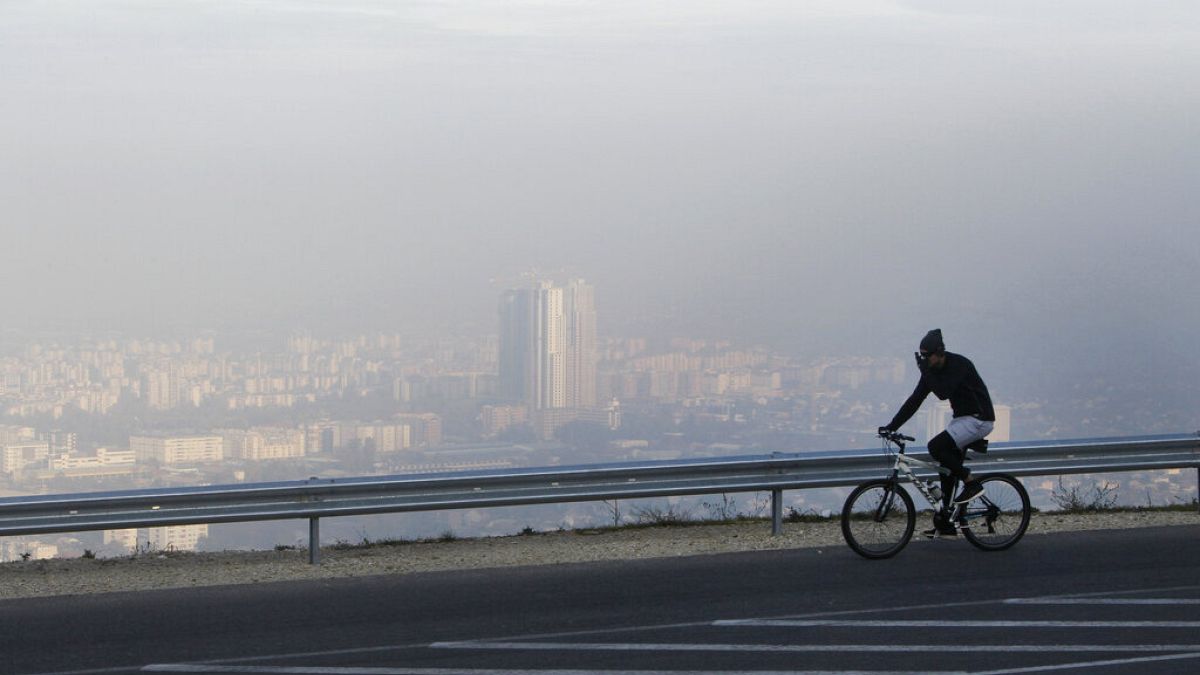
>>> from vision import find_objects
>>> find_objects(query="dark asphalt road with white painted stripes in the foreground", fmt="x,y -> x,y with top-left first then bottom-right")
0,526 -> 1200,675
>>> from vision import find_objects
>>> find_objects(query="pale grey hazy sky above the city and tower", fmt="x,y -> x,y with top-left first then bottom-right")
0,0 -> 1200,368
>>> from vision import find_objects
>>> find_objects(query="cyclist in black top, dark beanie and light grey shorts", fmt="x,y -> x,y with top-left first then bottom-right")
880,328 -> 996,537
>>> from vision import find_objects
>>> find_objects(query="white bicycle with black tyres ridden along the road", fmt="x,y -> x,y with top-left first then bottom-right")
841,431 -> 1031,560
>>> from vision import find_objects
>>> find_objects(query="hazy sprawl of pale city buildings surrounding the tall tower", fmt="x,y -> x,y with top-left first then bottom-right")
0,312 -> 1195,560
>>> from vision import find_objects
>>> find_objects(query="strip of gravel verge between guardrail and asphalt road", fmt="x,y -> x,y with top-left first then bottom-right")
0,510 -> 1200,599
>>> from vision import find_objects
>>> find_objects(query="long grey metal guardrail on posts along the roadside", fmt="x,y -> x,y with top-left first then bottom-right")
0,432 -> 1200,563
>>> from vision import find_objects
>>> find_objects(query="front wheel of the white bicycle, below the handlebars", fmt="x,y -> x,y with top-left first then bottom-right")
841,478 -> 917,560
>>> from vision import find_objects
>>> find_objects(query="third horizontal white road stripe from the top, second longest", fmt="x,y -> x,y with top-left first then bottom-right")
430,640 -> 1200,653
